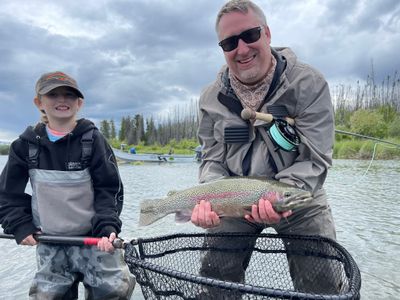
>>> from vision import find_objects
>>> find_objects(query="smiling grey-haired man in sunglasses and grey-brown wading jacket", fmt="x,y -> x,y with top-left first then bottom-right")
192,0 -> 340,293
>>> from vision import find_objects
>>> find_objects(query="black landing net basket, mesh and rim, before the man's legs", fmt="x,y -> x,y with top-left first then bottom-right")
125,233 -> 361,300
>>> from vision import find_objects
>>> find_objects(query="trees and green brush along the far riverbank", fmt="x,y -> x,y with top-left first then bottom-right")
100,66 -> 400,159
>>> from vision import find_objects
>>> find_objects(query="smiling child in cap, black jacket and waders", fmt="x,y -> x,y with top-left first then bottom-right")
0,72 -> 135,299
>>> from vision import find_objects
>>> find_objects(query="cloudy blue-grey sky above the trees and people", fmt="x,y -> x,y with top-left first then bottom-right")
0,0 -> 400,141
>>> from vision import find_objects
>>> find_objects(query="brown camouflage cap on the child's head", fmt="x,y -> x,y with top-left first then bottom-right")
35,71 -> 83,98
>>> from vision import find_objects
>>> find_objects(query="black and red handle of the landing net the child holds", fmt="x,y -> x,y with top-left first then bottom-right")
0,233 -> 124,248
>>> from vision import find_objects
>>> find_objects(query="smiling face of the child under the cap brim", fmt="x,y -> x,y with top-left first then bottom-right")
35,87 -> 82,122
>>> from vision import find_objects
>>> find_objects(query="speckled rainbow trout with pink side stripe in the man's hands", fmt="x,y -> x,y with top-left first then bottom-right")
139,177 -> 313,226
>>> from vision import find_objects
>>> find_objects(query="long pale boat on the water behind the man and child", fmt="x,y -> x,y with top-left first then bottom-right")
113,148 -> 198,163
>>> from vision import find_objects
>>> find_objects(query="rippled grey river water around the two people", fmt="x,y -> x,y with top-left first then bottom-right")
0,156 -> 400,300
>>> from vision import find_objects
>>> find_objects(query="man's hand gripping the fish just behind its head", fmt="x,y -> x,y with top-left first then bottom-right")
245,192 -> 292,224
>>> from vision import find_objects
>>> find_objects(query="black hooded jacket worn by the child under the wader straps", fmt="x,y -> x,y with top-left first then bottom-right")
0,119 -> 123,243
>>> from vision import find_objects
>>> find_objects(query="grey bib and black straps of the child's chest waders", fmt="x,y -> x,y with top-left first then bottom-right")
29,130 -> 95,235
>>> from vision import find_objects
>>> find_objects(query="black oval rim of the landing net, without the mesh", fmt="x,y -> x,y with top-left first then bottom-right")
125,233 -> 361,300
